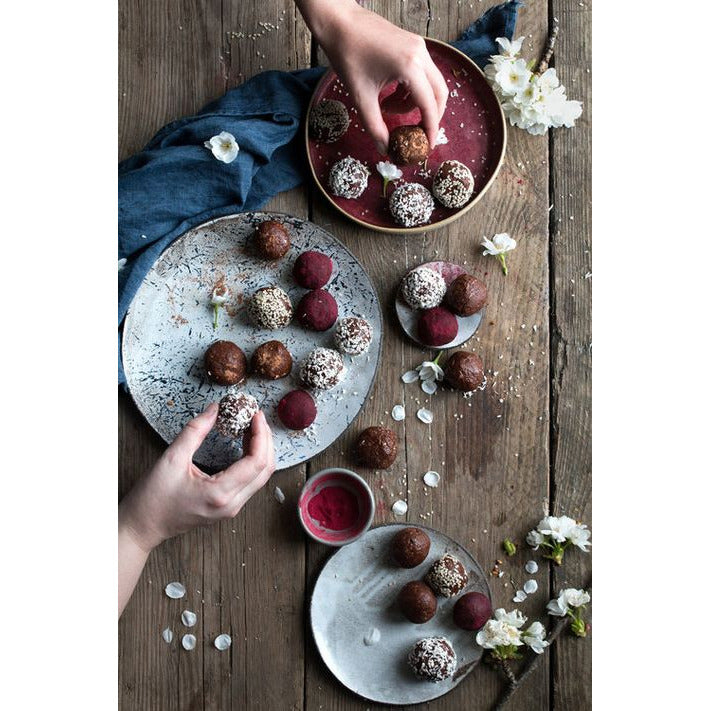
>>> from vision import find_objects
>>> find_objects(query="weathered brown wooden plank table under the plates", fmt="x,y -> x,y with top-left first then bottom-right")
119,0 -> 592,711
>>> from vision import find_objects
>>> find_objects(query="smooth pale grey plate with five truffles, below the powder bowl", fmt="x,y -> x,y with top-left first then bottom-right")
311,524 -> 491,705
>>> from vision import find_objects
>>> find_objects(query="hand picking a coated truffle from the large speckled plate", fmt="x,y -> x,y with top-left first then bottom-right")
119,403 -> 274,551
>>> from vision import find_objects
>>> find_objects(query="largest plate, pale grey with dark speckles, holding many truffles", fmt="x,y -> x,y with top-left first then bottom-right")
123,212 -> 382,469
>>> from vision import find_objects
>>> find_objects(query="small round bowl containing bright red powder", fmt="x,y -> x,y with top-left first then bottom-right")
299,467 -> 375,546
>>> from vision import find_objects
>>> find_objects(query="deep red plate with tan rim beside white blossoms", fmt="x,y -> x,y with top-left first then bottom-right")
305,38 -> 506,234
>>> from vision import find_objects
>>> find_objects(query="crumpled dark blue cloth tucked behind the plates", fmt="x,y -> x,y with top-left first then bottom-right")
118,0 -> 522,383
